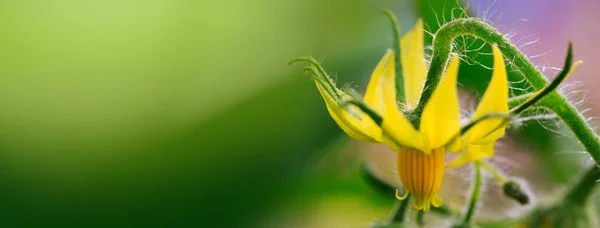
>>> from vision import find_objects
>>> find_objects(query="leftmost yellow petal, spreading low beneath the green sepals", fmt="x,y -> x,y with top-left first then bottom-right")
315,80 -> 381,142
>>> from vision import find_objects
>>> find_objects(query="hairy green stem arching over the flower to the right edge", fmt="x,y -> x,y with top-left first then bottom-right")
412,18 -> 600,164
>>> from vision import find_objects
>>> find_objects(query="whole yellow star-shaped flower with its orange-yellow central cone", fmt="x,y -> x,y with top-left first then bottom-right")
308,20 -> 508,211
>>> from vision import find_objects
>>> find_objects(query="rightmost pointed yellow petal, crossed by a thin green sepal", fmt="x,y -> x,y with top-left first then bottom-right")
466,45 -> 508,143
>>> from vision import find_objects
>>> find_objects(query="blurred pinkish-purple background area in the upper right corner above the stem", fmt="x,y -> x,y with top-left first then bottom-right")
478,0 -> 600,109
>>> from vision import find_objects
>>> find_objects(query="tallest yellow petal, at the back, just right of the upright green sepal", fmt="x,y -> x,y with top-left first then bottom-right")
400,19 -> 427,108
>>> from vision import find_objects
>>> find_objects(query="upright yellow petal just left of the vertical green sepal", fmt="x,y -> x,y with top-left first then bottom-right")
365,49 -> 396,114
